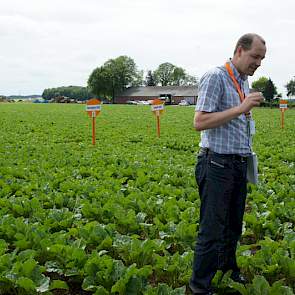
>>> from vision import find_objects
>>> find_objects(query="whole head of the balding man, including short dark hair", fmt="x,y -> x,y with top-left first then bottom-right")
232,33 -> 266,76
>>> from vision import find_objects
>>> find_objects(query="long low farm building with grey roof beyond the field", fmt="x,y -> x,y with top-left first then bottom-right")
115,86 -> 198,104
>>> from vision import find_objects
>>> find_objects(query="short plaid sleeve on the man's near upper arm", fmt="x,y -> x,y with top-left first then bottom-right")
195,70 -> 223,113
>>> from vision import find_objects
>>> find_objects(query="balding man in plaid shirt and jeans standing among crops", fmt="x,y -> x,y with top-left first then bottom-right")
190,34 -> 266,294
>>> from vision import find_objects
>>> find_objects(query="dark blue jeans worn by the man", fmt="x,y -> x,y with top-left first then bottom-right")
190,150 -> 247,292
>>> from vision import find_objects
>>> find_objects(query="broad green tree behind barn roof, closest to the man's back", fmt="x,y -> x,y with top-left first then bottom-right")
154,62 -> 197,86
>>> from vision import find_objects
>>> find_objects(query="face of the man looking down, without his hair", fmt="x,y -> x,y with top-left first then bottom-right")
237,38 -> 266,76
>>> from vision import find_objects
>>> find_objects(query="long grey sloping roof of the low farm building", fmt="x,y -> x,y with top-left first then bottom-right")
118,86 -> 198,96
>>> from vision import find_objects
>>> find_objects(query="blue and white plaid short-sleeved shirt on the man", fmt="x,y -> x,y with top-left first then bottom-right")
195,62 -> 251,155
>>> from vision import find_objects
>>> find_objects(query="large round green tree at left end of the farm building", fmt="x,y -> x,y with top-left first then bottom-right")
87,56 -> 143,103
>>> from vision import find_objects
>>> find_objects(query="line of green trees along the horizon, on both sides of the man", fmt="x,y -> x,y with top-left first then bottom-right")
42,55 -> 295,103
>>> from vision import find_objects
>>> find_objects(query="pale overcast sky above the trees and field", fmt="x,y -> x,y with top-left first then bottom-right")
0,0 -> 295,95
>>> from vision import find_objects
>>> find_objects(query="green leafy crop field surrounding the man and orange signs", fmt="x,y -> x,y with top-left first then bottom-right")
0,103 -> 295,295
